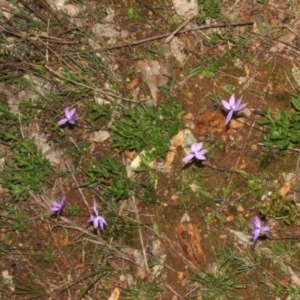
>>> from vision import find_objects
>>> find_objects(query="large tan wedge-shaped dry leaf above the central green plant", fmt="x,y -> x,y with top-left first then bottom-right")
137,60 -> 169,104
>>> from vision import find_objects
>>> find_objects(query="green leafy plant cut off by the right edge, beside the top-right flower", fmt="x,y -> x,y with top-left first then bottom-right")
259,93 -> 300,150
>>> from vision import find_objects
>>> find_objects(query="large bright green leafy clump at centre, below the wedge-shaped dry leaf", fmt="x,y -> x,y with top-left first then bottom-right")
112,100 -> 182,157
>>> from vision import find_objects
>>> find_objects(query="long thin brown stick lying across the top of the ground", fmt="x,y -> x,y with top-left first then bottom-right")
100,21 -> 254,52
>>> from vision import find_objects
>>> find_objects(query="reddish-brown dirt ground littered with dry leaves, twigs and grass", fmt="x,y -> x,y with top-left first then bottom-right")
0,0 -> 300,300
